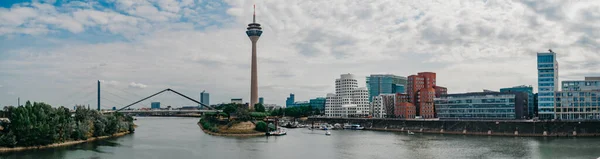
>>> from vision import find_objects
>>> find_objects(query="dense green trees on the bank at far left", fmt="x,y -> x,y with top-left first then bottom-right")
0,101 -> 135,152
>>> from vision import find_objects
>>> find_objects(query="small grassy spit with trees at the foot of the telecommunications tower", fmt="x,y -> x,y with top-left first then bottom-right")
198,103 -> 320,137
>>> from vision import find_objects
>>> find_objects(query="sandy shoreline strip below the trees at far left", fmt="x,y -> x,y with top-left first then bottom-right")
0,131 -> 130,153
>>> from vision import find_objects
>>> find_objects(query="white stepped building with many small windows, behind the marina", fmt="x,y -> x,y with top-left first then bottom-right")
325,74 -> 370,117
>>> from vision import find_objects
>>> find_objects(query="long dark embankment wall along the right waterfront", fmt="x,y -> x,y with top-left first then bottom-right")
308,118 -> 600,137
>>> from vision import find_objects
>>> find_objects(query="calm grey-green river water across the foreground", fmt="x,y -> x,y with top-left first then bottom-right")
0,117 -> 600,159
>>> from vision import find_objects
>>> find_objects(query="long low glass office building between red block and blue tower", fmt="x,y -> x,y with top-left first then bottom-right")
435,92 -> 528,120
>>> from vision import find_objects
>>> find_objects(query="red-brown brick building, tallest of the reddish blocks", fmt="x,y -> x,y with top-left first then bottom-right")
406,72 -> 448,119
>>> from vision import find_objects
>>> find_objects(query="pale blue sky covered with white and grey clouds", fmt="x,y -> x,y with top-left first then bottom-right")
0,0 -> 600,108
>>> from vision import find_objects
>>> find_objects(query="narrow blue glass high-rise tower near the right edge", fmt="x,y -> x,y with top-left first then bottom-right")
537,50 -> 559,119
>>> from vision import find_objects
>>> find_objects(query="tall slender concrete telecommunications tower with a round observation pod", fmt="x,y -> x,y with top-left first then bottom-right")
246,5 -> 262,109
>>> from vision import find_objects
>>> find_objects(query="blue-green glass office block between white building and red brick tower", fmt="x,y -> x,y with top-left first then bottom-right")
366,74 -> 406,101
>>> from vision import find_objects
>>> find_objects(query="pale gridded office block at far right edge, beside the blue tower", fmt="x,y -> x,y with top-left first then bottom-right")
555,77 -> 600,120
